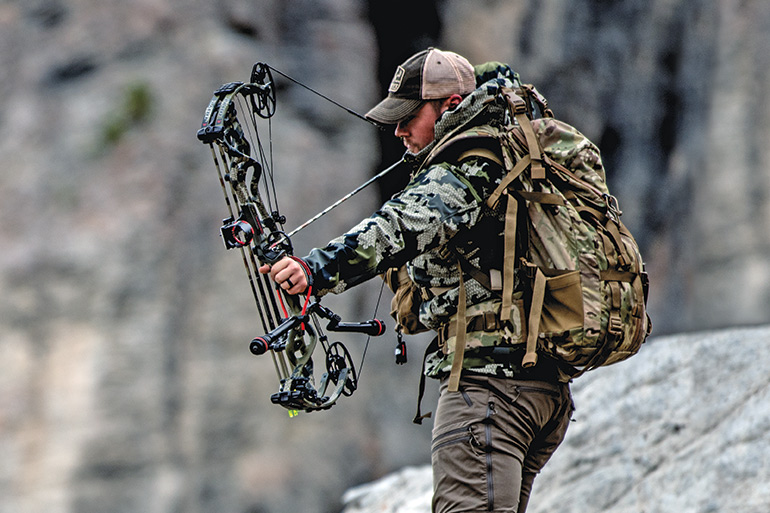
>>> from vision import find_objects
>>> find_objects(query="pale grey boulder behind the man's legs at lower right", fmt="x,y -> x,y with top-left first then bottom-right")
343,327 -> 770,513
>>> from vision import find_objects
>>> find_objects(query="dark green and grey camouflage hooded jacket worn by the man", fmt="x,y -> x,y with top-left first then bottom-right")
304,63 -> 544,377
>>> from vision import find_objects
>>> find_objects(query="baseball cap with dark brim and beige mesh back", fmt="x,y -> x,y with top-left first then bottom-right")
366,48 -> 476,125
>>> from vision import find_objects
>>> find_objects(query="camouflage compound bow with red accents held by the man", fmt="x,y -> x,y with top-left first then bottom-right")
198,63 -> 388,412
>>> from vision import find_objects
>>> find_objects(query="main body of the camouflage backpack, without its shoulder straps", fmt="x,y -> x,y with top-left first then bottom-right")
498,115 -> 649,368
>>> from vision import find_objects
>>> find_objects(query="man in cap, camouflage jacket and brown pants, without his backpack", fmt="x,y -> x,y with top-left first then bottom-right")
260,48 -> 573,513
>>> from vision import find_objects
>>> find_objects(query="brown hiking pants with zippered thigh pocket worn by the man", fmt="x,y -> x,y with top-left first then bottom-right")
431,376 -> 574,513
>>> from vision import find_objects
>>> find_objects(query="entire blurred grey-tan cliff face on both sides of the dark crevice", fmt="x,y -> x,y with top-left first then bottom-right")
0,0 -> 770,513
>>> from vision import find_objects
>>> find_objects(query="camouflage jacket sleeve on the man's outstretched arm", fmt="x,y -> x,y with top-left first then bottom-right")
304,164 -> 481,295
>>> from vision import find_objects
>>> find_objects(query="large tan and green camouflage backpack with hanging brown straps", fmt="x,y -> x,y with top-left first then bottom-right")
428,85 -> 652,384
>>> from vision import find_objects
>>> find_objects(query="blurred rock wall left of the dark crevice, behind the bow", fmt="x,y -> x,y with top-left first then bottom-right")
0,0 -> 396,513
